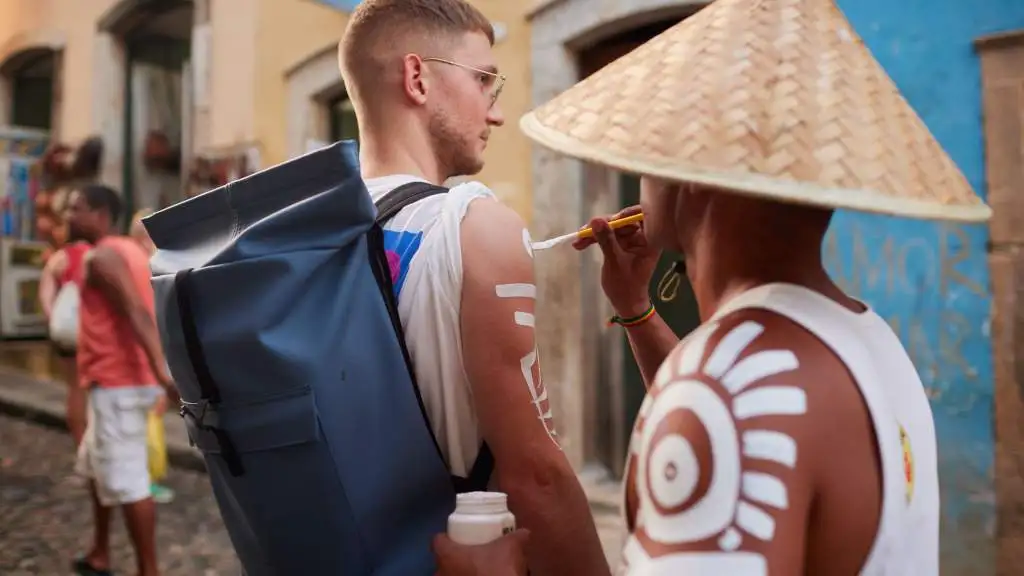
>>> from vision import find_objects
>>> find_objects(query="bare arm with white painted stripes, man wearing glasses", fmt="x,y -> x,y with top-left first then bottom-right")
461,199 -> 609,576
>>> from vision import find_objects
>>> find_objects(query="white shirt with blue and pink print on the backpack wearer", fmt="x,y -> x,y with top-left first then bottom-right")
366,174 -> 494,477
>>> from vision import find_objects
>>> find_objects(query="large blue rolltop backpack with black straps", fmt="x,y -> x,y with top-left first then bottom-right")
143,141 -> 493,576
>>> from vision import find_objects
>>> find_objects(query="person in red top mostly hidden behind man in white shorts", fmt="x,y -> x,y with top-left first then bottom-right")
39,231 -> 89,448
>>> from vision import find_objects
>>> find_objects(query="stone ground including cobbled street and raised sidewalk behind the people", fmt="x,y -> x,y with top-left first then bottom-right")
0,366 -> 624,565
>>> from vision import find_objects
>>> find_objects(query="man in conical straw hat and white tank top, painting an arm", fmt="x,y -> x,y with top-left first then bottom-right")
428,0 -> 990,576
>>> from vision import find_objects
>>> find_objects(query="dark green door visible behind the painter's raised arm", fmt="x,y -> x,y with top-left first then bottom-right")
612,174 -> 700,470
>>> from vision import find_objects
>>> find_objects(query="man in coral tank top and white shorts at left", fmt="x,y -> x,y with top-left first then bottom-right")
69,184 -> 176,576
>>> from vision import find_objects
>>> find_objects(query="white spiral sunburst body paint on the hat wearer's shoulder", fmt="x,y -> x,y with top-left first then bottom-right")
624,321 -> 807,576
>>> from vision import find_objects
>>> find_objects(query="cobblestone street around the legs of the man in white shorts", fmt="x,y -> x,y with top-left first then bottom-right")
0,415 -> 239,576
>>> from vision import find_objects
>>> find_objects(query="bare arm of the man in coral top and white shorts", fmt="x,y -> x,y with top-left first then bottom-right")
86,248 -> 171,387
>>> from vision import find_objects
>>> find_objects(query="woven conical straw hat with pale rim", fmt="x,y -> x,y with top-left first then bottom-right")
520,0 -> 991,221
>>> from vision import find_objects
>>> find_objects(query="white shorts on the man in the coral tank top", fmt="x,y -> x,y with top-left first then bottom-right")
75,385 -> 163,506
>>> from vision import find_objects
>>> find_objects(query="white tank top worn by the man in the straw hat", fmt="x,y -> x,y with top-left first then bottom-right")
624,284 -> 939,576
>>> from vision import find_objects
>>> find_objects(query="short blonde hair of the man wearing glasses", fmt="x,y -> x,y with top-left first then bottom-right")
339,0 -> 495,110
